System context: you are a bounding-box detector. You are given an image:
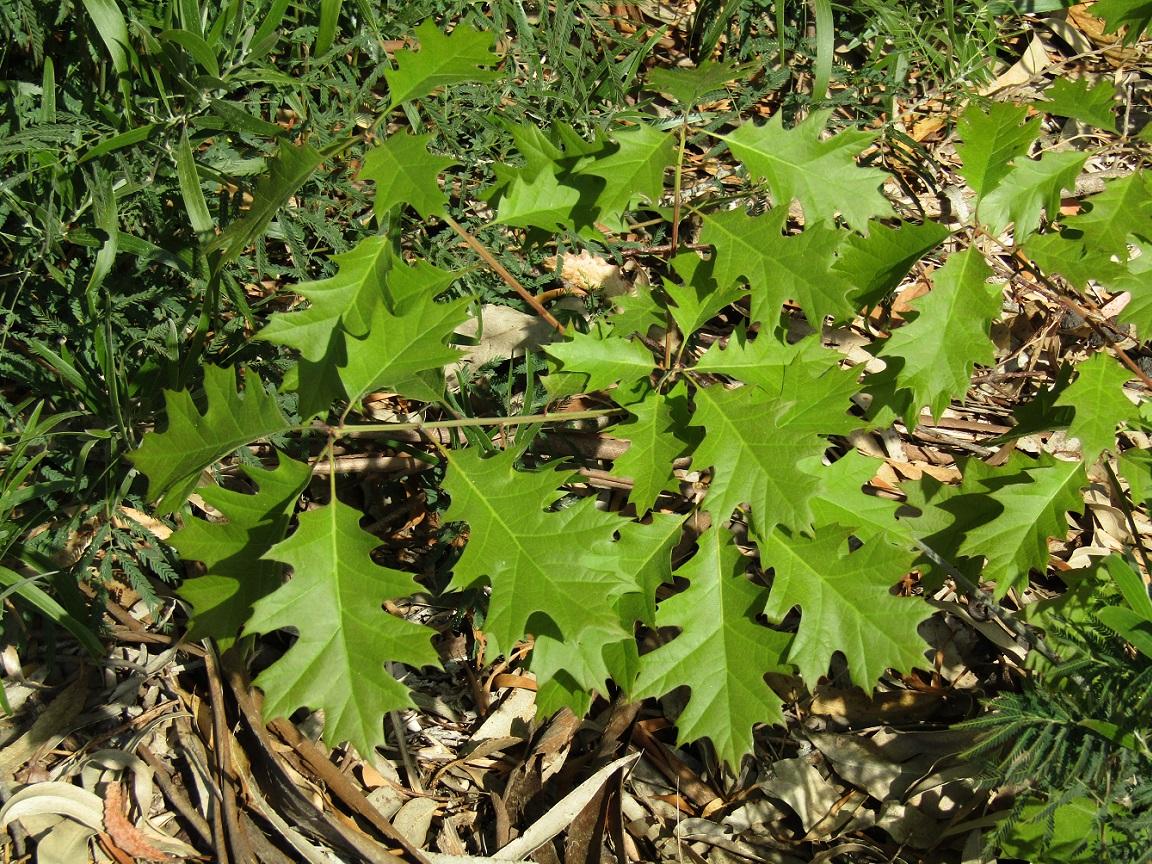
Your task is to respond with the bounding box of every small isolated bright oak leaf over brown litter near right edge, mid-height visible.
[1054,351,1140,464]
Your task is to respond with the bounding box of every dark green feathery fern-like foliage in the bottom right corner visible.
[965,576,1152,864]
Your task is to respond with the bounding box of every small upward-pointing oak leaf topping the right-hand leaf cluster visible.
[956,103,1040,197]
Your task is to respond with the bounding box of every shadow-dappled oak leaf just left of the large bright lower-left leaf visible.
[168,453,312,651]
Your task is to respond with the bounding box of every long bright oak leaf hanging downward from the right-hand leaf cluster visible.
[870,249,1002,429]
